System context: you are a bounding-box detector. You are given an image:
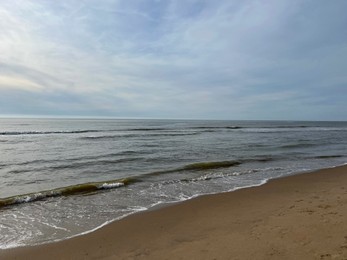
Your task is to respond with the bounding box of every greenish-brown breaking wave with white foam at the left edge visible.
[0,178,137,208]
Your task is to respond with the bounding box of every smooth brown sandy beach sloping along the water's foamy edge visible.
[0,166,347,260]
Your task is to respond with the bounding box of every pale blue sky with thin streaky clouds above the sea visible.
[0,0,347,120]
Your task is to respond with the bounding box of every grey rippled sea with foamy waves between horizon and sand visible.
[0,119,347,248]
